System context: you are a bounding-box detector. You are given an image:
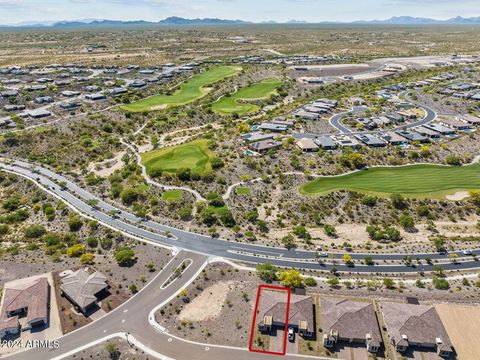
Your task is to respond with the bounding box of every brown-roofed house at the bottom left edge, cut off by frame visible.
[0,277,50,338]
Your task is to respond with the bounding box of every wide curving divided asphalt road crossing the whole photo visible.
[0,160,480,274]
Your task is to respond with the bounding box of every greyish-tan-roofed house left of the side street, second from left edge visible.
[60,268,108,314]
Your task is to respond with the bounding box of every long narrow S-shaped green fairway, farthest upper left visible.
[121,66,242,112]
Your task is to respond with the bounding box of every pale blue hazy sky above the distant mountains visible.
[0,0,480,24]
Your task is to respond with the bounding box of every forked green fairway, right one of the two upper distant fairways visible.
[212,79,282,116]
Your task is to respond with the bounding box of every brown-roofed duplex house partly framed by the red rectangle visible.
[257,291,315,338]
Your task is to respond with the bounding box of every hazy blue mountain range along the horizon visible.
[0,16,480,29]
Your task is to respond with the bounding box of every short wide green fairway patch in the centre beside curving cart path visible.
[142,139,214,174]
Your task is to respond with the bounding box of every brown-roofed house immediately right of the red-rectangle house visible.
[320,298,382,353]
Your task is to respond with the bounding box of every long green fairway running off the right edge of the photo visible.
[299,163,480,199]
